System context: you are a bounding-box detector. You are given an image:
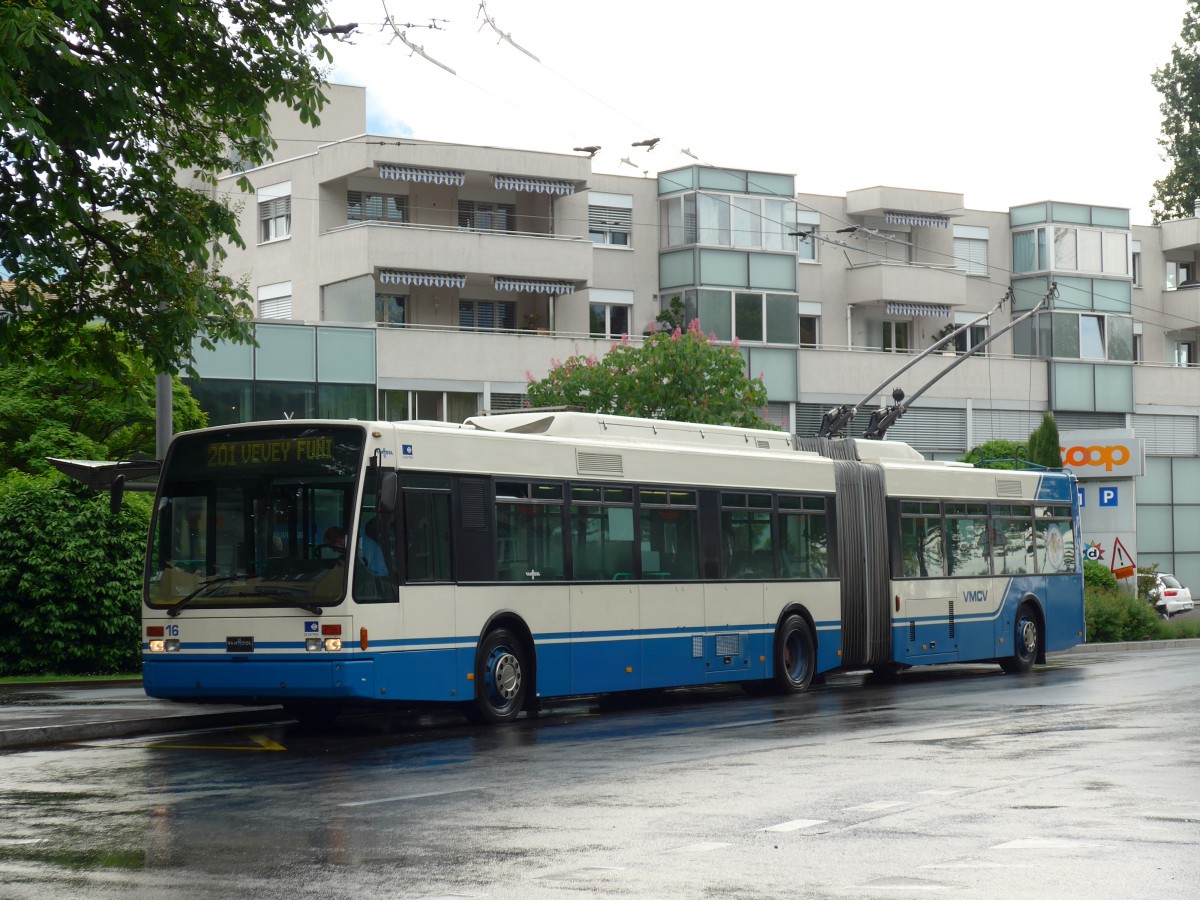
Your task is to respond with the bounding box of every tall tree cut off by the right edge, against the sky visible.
[1150,0,1200,224]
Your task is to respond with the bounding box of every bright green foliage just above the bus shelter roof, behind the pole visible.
[0,329,205,480]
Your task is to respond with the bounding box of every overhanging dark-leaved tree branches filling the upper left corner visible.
[0,0,330,373]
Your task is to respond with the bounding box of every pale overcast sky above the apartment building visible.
[329,0,1188,224]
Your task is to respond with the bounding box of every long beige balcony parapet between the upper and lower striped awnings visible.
[317,222,594,284]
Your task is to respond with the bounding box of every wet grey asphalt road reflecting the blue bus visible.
[0,648,1200,900]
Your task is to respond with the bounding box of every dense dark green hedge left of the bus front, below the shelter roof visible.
[0,473,151,676]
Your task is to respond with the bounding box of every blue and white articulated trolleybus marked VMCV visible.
[143,410,1084,722]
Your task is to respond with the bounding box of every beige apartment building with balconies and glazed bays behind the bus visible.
[184,85,1200,586]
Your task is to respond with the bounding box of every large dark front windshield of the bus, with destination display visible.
[146,425,365,614]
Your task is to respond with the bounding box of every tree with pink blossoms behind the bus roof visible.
[526,319,769,428]
